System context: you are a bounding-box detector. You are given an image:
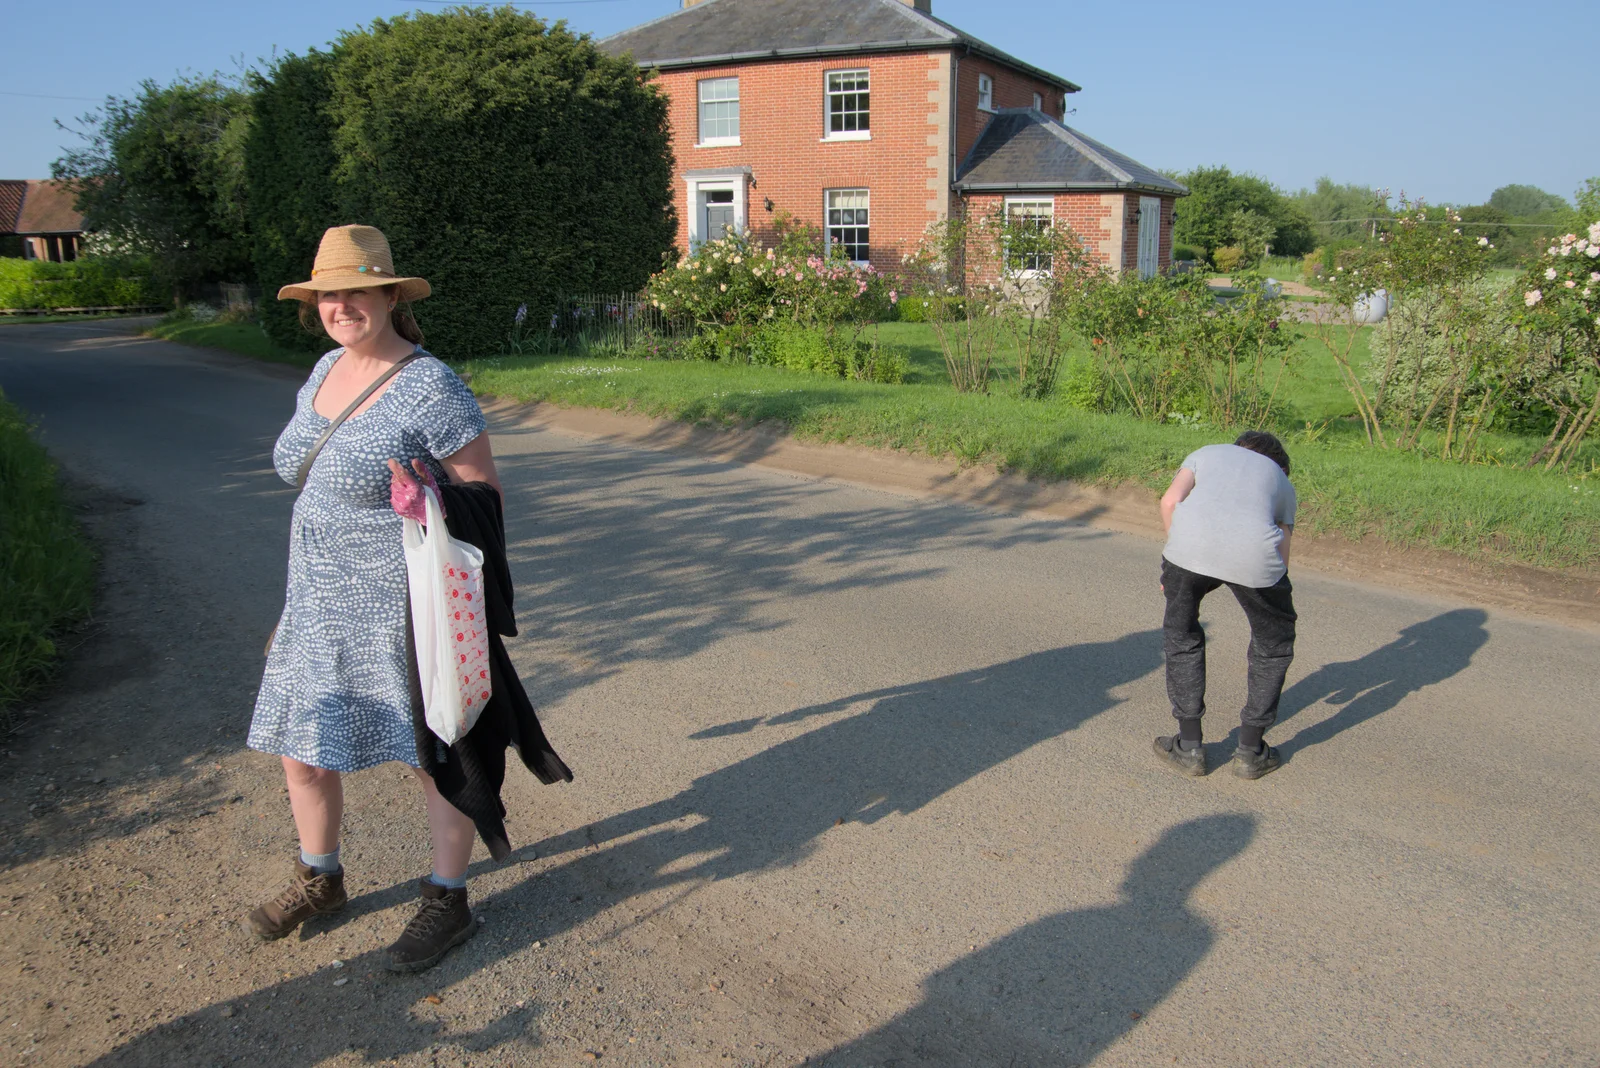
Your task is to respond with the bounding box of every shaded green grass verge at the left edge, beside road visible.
[0,393,94,735]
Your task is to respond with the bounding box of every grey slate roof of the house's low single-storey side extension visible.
[954,107,1189,197]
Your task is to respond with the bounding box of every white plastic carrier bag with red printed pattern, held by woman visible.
[405,486,491,745]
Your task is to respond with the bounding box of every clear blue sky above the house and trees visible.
[0,0,1600,203]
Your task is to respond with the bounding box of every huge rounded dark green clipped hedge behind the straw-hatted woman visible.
[245,8,675,360]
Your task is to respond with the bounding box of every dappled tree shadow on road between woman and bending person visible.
[498,430,1107,713]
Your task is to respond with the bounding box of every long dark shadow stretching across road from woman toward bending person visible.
[538,630,1162,886]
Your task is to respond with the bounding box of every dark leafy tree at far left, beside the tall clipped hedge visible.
[53,75,250,302]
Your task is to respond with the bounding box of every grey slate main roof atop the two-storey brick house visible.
[597,0,1080,93]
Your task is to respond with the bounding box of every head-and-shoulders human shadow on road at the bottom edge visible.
[814,815,1256,1068]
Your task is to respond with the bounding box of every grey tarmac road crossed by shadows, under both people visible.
[0,323,1600,1066]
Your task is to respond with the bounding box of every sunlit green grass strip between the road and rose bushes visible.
[140,314,1600,571]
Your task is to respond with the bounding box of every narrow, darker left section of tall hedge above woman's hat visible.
[245,51,346,349]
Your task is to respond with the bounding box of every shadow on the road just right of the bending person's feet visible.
[1277,608,1490,756]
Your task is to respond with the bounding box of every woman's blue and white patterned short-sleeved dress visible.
[248,349,485,771]
